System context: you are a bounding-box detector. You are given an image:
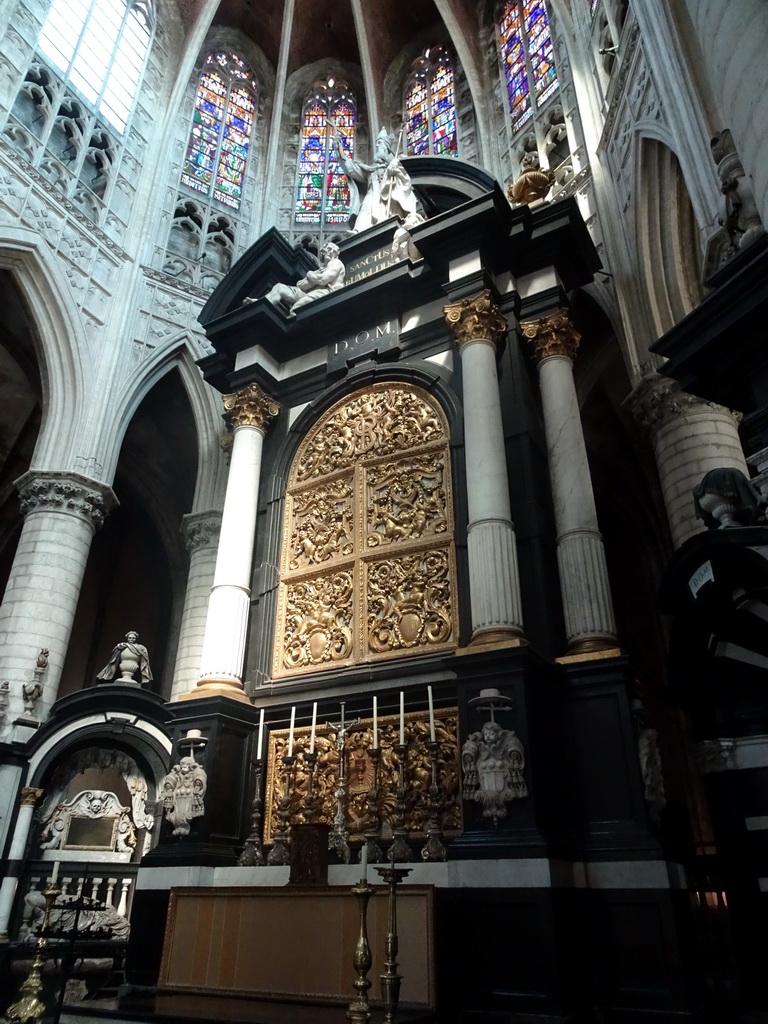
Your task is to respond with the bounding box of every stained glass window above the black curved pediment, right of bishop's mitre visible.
[404,46,458,157]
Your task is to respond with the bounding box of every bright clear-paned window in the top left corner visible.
[38,0,154,132]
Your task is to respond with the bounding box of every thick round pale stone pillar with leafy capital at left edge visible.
[0,470,118,721]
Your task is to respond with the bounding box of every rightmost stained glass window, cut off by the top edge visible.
[499,0,558,131]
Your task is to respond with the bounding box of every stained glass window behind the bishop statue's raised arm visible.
[294,80,355,226]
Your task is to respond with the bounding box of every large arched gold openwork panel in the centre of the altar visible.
[273,384,458,676]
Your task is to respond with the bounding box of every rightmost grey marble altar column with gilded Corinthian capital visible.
[520,309,617,654]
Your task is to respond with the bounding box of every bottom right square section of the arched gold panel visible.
[364,549,455,654]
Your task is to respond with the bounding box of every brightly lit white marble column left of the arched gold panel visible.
[179,384,280,700]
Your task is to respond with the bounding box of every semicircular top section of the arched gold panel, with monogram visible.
[292,384,445,483]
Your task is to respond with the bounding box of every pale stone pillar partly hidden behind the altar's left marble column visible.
[171,510,221,700]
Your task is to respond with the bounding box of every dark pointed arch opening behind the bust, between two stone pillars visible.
[59,370,198,697]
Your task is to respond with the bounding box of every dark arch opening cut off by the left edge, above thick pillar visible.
[0,270,42,595]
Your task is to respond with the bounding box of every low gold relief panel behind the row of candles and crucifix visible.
[264,708,463,844]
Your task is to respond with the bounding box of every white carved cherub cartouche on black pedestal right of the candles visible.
[462,722,528,826]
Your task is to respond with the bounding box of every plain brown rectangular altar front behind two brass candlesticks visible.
[158,886,435,1009]
